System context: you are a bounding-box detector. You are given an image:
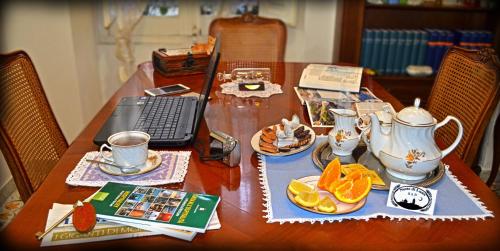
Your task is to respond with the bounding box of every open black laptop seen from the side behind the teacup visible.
[94,43,220,147]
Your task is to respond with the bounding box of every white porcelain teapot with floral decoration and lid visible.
[370,98,463,180]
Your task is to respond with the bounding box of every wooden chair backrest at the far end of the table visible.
[209,13,287,62]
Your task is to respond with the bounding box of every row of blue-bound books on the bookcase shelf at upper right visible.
[361,29,493,75]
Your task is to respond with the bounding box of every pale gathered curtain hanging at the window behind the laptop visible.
[103,0,147,82]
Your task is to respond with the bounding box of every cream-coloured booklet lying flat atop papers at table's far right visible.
[299,64,363,92]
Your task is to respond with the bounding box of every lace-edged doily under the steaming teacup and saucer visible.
[66,151,191,187]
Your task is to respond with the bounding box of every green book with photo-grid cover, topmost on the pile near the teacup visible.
[90,182,220,233]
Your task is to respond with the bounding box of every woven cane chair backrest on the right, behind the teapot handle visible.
[427,47,500,166]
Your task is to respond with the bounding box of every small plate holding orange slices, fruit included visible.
[287,159,372,215]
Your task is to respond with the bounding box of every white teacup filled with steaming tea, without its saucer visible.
[99,131,151,170]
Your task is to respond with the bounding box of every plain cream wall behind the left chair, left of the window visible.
[0,1,103,196]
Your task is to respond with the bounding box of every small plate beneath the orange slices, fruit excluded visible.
[286,176,366,215]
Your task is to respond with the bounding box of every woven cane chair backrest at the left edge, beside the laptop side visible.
[0,51,68,201]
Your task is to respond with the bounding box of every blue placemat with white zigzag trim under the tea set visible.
[259,136,493,223]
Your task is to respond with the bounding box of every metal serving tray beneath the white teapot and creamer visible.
[312,142,445,190]
